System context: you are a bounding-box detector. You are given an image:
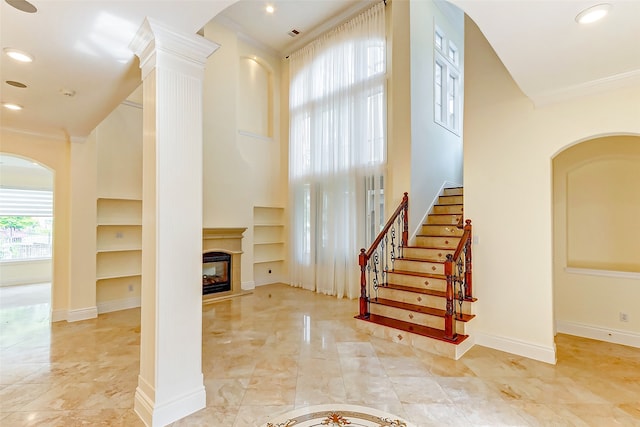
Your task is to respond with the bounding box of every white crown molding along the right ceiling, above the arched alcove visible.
[530,70,640,107]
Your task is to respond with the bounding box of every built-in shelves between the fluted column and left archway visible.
[96,198,142,302]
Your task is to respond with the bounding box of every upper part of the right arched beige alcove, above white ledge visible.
[553,135,640,272]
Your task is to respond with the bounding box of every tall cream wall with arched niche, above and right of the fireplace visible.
[203,20,288,288]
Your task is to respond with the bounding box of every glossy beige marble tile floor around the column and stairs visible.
[0,284,640,427]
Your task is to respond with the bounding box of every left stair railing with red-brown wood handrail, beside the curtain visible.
[358,193,409,319]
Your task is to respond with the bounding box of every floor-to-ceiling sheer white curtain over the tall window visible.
[289,2,386,298]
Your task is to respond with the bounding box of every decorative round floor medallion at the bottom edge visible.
[263,405,415,427]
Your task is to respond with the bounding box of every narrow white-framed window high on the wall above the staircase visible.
[433,27,460,133]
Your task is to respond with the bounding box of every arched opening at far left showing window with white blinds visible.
[0,154,54,335]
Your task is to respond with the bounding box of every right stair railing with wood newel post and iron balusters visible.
[444,219,474,341]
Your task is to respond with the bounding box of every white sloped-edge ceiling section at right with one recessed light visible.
[451,0,640,105]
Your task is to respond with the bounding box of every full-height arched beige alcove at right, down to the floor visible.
[553,136,640,343]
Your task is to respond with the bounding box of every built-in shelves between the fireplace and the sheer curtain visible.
[253,206,285,285]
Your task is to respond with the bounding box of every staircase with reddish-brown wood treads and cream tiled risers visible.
[357,187,475,359]
